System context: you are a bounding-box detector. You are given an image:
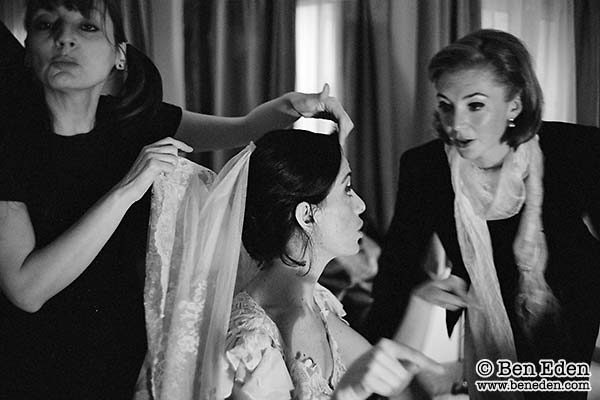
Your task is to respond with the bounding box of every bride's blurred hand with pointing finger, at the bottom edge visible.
[332,339,444,400]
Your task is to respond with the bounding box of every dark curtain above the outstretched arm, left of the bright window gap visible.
[184,0,296,170]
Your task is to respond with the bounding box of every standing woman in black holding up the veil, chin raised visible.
[0,0,351,400]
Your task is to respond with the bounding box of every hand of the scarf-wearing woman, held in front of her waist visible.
[413,275,470,311]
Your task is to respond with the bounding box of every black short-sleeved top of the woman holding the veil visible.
[0,97,181,400]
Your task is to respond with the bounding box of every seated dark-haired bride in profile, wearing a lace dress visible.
[226,132,384,399]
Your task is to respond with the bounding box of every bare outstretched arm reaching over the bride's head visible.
[175,85,354,151]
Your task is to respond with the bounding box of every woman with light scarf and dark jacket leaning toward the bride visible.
[366,30,600,399]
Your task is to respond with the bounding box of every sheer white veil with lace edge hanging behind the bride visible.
[135,143,255,400]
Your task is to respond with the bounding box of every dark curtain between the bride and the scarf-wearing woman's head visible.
[342,0,480,234]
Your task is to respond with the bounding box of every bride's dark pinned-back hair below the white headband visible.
[242,130,342,266]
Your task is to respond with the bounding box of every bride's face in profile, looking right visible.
[312,157,365,258]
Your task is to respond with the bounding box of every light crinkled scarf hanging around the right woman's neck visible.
[446,136,558,399]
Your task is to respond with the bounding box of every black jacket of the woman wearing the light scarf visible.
[365,122,600,398]
